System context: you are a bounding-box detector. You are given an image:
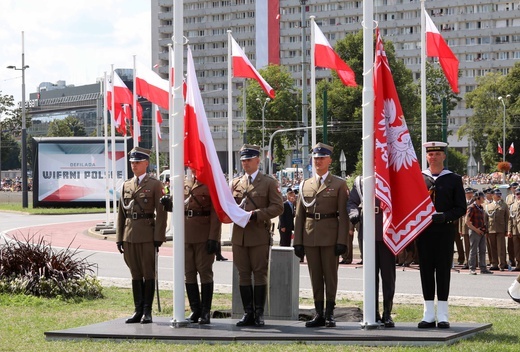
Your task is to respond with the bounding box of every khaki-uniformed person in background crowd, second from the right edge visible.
[484,189,509,271]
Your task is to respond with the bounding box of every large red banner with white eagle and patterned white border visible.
[374,30,435,255]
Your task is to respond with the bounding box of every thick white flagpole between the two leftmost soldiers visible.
[170,1,187,327]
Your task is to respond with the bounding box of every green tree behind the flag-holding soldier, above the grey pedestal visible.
[243,65,301,172]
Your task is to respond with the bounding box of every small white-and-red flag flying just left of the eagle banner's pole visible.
[313,22,357,87]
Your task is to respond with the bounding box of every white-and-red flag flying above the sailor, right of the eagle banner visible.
[424,10,459,94]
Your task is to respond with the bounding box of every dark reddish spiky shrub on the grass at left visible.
[0,236,103,300]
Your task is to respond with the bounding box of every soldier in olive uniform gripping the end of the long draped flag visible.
[231,144,283,326]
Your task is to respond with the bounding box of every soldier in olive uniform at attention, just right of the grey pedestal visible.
[294,143,350,327]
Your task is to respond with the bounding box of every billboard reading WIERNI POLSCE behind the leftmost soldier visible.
[33,137,132,207]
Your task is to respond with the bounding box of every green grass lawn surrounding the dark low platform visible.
[0,287,520,352]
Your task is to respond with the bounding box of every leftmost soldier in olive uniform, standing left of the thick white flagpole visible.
[116,147,166,324]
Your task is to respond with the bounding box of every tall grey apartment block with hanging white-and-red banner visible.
[151,0,520,170]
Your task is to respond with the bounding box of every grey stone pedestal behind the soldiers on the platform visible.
[231,246,300,320]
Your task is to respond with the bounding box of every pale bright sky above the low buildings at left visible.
[0,0,151,102]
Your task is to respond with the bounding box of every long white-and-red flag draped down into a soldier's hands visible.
[184,46,251,227]
